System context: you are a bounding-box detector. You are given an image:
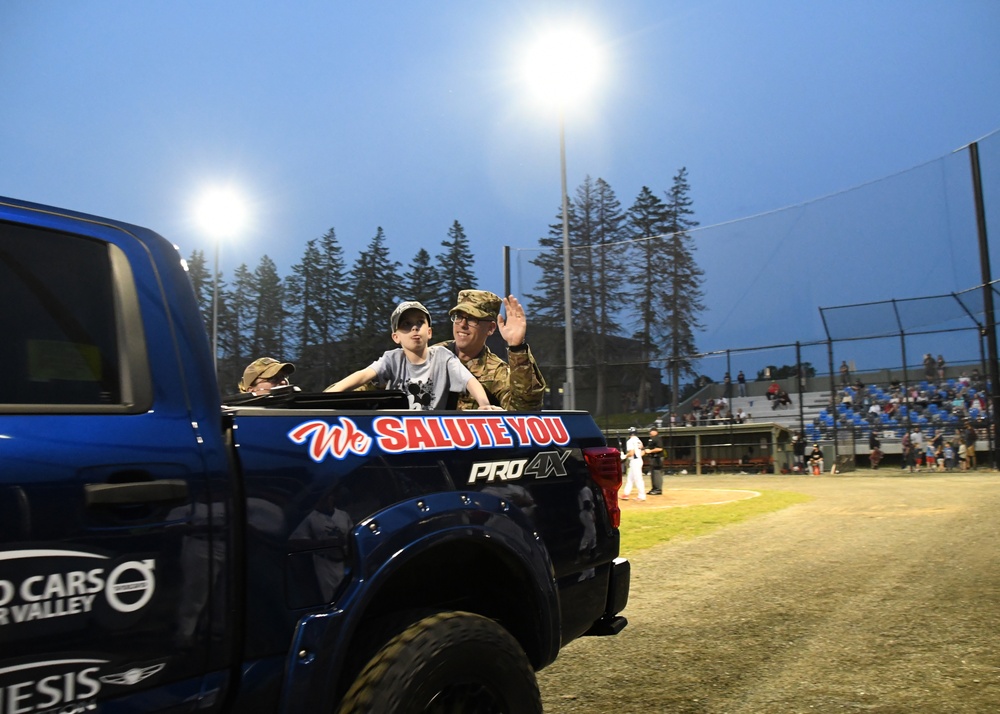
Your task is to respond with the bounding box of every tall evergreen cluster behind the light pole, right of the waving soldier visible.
[527,168,704,414]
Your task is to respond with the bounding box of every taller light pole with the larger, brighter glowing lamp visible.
[524,26,604,409]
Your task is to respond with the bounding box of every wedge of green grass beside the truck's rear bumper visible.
[621,491,813,556]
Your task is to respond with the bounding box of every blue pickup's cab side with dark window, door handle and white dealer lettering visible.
[0,207,227,714]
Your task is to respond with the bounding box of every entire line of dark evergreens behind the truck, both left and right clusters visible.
[188,168,704,414]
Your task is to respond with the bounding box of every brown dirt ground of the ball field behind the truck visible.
[538,469,1000,714]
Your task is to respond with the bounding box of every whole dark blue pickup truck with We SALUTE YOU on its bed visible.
[0,198,629,714]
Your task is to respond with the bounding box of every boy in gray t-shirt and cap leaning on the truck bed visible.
[326,300,495,409]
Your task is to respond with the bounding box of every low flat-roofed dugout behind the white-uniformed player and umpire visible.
[605,422,793,474]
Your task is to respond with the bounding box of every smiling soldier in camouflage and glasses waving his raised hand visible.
[441,290,545,411]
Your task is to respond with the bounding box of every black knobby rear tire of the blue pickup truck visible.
[337,612,542,714]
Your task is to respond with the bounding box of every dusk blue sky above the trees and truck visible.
[0,0,1000,378]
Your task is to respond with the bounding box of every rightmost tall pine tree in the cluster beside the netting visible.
[658,168,705,408]
